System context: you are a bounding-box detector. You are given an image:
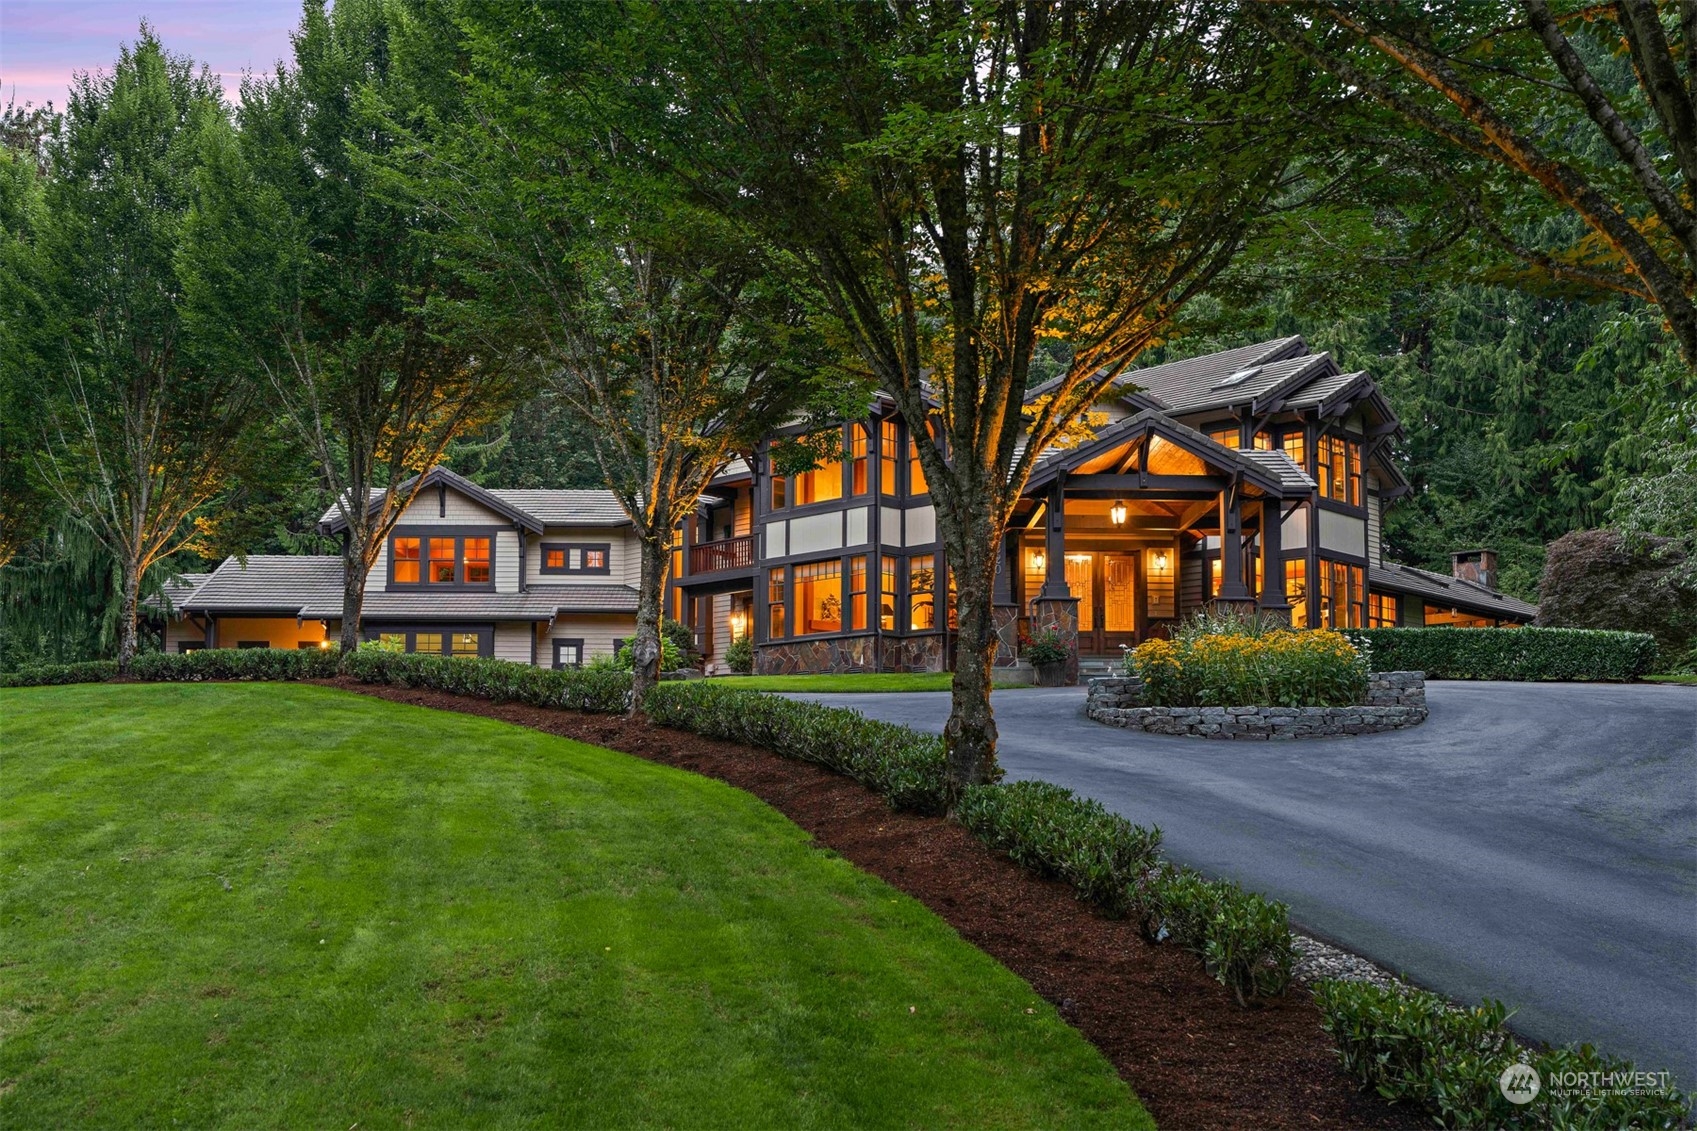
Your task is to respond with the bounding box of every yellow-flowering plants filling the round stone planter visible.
[1127,618,1368,706]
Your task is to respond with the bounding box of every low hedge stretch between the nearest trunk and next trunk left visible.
[645,679,947,813]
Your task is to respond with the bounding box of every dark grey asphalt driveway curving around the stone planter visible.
[794,683,1697,1089]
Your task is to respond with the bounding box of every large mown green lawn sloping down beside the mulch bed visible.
[0,684,1151,1128]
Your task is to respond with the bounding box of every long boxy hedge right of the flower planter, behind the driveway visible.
[1344,628,1656,681]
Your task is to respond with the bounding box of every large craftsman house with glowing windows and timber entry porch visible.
[156,336,1537,672]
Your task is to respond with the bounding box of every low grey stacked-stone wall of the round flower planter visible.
[1084,671,1427,740]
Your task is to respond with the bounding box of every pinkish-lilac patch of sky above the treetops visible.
[0,0,300,110]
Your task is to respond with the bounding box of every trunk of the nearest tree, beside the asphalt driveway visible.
[938,540,1001,791]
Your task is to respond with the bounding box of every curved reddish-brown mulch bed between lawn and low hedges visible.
[329,679,1425,1128]
